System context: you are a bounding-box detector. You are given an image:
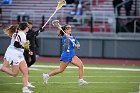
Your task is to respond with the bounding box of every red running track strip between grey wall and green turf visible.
[0,56,140,65]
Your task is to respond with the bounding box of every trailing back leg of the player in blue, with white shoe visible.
[43,61,69,84]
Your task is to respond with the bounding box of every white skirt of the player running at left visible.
[4,47,25,65]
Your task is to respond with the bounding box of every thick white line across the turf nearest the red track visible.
[30,65,140,71]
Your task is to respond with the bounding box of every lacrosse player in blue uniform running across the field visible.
[43,25,88,85]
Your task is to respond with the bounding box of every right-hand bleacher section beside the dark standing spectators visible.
[79,0,136,32]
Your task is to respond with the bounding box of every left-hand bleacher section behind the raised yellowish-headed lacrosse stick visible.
[0,0,72,30]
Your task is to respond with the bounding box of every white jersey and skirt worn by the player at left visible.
[4,31,26,65]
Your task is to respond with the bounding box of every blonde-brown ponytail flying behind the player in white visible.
[4,25,18,37]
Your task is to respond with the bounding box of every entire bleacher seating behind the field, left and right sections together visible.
[0,0,135,32]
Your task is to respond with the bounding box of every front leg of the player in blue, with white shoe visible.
[72,56,87,85]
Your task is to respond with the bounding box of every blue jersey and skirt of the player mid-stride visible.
[60,35,78,62]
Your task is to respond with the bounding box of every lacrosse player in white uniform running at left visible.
[1,23,33,93]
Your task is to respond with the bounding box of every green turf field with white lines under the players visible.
[0,62,140,93]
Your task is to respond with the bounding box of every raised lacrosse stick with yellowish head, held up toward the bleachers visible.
[42,0,66,29]
